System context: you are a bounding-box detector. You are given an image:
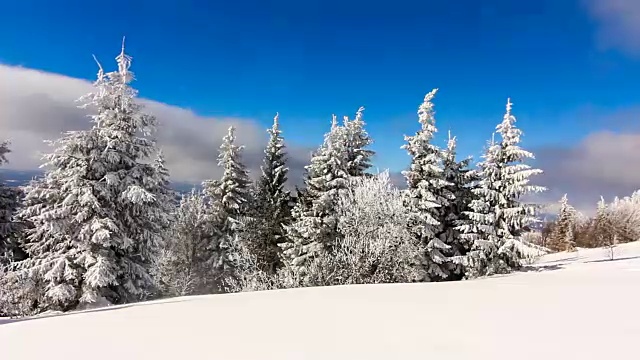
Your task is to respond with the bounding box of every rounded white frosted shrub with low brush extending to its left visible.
[227,172,425,291]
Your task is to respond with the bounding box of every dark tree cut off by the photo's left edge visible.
[0,141,23,266]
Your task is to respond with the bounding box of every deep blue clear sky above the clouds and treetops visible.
[0,0,640,174]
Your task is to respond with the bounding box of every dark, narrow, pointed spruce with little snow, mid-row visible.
[241,114,291,273]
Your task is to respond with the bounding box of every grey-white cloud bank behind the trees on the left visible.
[0,65,309,183]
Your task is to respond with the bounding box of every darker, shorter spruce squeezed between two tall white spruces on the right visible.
[438,134,478,280]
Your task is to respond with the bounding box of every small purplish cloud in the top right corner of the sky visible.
[584,0,640,55]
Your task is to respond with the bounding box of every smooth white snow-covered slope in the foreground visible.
[0,243,640,360]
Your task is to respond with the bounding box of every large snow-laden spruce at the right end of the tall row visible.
[460,100,545,277]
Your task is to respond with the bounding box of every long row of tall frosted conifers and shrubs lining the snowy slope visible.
[0,43,544,315]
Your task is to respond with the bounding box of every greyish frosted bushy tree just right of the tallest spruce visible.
[155,190,220,296]
